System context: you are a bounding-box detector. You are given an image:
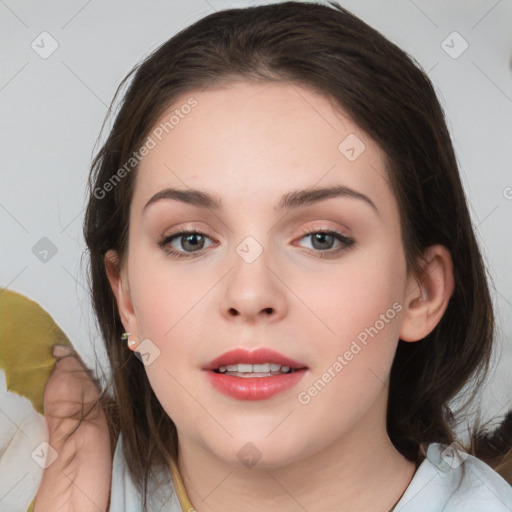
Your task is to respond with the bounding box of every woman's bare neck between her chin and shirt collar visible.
[174,402,416,512]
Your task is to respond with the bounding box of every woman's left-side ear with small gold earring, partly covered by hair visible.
[104,250,139,350]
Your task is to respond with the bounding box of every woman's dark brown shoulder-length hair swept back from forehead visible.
[84,2,510,504]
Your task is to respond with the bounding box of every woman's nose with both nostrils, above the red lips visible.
[220,244,288,324]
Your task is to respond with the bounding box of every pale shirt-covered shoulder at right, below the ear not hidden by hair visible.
[393,443,512,512]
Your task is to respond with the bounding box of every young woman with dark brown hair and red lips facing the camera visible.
[37,2,512,512]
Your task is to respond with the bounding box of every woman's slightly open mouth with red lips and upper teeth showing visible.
[202,348,308,400]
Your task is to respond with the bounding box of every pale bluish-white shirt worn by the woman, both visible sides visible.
[110,436,512,512]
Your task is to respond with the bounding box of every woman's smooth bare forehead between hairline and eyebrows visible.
[133,82,391,214]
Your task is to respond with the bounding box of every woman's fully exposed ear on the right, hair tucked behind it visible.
[400,245,454,341]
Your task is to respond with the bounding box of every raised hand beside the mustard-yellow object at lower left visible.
[34,346,112,512]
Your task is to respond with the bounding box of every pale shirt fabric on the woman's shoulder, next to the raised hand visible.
[109,434,181,512]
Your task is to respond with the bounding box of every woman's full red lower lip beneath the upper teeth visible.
[206,368,307,400]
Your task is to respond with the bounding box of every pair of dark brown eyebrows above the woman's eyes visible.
[143,185,380,215]
